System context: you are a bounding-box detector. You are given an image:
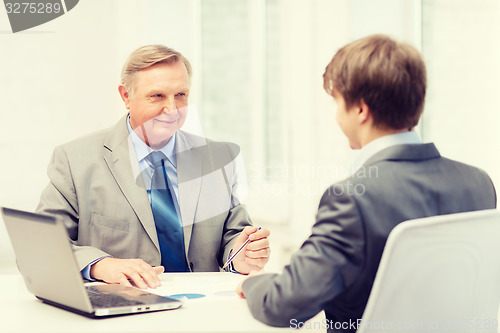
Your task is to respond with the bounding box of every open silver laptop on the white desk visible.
[2,208,182,318]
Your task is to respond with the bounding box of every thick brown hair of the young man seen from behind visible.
[323,35,427,130]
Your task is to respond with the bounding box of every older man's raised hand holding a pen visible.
[232,227,271,274]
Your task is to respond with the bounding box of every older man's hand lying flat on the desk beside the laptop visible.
[90,258,164,289]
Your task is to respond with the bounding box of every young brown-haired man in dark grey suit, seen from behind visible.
[237,35,496,332]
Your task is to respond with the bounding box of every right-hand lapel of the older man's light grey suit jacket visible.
[175,131,203,252]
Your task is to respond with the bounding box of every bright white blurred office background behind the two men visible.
[0,0,500,272]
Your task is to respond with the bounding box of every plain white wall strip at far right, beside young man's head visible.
[423,0,500,189]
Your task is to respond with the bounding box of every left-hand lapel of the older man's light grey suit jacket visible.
[104,117,160,251]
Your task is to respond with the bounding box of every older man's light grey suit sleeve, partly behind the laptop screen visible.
[36,147,109,270]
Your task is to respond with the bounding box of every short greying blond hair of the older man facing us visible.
[121,45,192,93]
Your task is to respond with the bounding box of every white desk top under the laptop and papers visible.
[0,273,326,333]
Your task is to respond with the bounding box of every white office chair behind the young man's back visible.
[358,210,500,333]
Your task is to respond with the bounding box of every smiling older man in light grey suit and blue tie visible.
[38,45,269,288]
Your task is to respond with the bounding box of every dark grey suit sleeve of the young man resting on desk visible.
[243,187,365,327]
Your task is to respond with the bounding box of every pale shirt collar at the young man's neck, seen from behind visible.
[349,131,422,174]
